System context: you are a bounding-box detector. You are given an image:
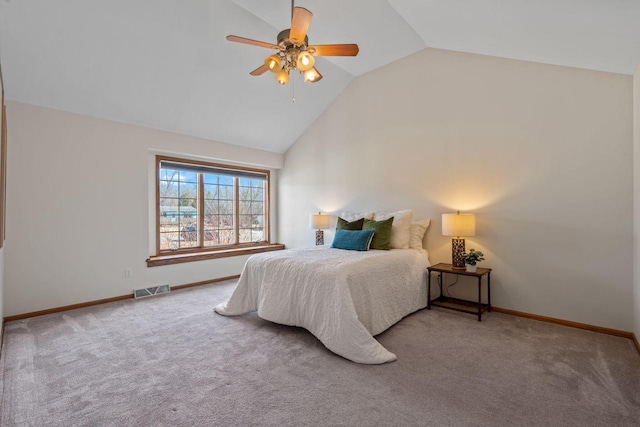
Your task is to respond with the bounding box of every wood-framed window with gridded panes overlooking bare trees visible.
[156,156,269,255]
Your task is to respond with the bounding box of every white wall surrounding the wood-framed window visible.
[4,102,283,316]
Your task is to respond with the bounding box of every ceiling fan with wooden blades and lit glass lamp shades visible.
[227,0,359,85]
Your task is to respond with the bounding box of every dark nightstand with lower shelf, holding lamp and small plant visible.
[427,263,491,322]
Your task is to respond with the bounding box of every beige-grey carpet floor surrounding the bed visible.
[0,282,640,426]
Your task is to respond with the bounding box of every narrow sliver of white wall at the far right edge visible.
[633,65,640,339]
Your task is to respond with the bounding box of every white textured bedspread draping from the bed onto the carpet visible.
[215,246,429,364]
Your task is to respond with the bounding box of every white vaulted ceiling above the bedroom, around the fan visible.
[0,0,640,152]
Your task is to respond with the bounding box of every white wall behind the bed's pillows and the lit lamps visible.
[278,49,633,331]
